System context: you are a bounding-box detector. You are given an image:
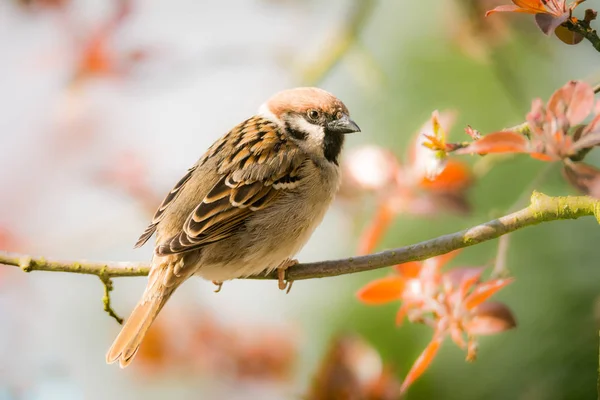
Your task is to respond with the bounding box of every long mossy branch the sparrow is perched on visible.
[0,192,600,284]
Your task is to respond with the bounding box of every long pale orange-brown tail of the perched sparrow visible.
[106,291,172,368]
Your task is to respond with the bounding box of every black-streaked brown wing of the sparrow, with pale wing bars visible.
[156,117,305,255]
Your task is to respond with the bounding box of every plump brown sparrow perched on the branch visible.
[106,87,360,368]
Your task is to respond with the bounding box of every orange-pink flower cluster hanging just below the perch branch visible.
[357,251,516,392]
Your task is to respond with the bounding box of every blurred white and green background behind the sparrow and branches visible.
[0,0,600,400]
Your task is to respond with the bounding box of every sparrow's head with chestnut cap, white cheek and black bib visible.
[259,87,360,164]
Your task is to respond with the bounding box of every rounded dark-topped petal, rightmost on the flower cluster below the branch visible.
[466,302,517,335]
